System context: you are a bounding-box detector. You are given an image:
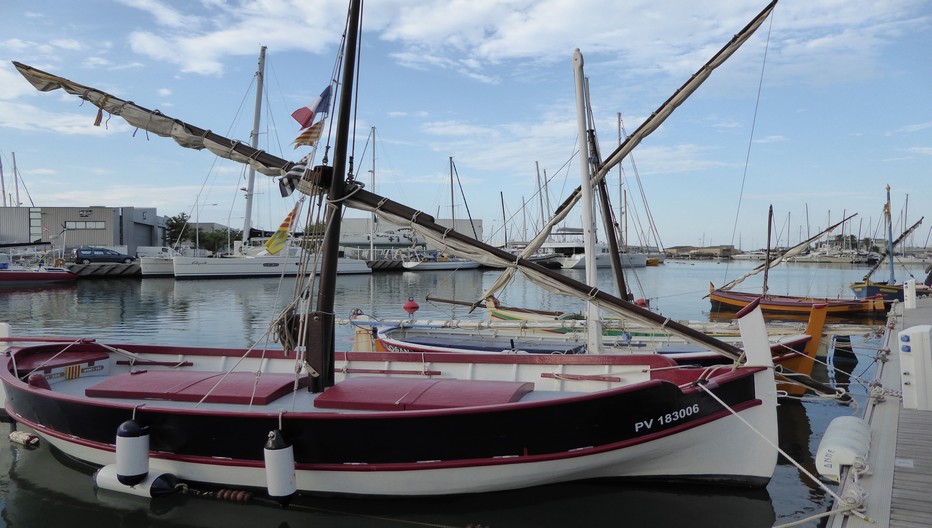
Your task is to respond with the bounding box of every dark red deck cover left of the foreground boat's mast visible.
[84,370,307,405]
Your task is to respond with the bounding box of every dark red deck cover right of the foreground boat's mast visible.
[314,377,534,411]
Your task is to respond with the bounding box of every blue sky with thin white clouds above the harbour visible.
[0,0,932,250]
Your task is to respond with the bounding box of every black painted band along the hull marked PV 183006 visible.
[5,368,759,469]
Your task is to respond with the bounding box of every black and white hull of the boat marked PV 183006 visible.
[0,344,776,495]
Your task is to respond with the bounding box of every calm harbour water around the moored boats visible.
[0,261,896,528]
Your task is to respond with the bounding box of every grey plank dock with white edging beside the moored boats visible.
[816,288,932,528]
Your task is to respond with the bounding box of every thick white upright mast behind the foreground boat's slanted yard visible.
[573,48,602,354]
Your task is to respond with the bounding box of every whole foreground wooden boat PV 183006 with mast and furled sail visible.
[0,0,777,502]
